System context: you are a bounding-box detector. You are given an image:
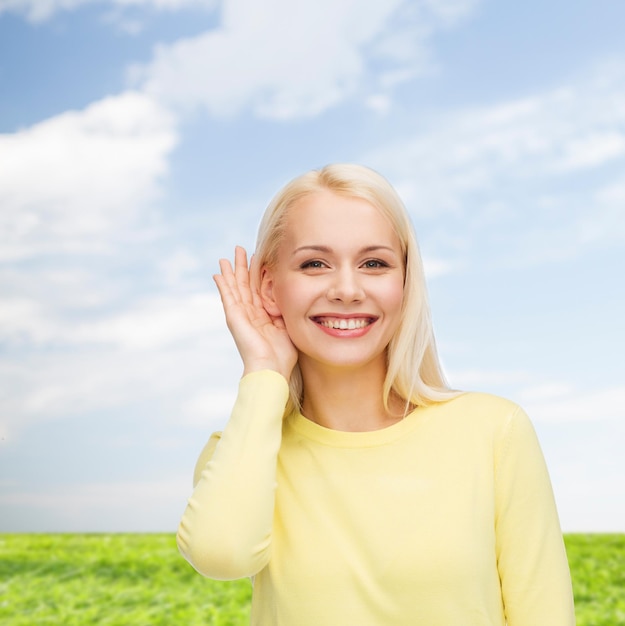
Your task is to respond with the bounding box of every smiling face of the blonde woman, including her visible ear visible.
[261,191,404,368]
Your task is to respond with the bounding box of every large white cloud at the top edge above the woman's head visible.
[131,0,476,119]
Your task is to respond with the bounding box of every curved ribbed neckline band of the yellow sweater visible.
[287,407,427,448]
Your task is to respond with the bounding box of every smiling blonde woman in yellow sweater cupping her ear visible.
[178,165,575,626]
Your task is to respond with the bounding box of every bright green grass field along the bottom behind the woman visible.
[0,534,625,626]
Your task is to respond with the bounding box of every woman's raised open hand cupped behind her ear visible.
[213,246,297,380]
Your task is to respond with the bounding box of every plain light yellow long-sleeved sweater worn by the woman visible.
[178,371,575,626]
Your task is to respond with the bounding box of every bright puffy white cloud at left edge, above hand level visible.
[0,92,177,260]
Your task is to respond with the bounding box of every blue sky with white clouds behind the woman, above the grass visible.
[0,0,625,531]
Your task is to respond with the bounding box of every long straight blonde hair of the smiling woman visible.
[255,164,457,413]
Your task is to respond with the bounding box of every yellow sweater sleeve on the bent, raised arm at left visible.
[176,370,289,580]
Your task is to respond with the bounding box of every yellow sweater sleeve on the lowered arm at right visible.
[495,408,575,626]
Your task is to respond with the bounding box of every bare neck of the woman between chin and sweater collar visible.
[300,356,405,432]
